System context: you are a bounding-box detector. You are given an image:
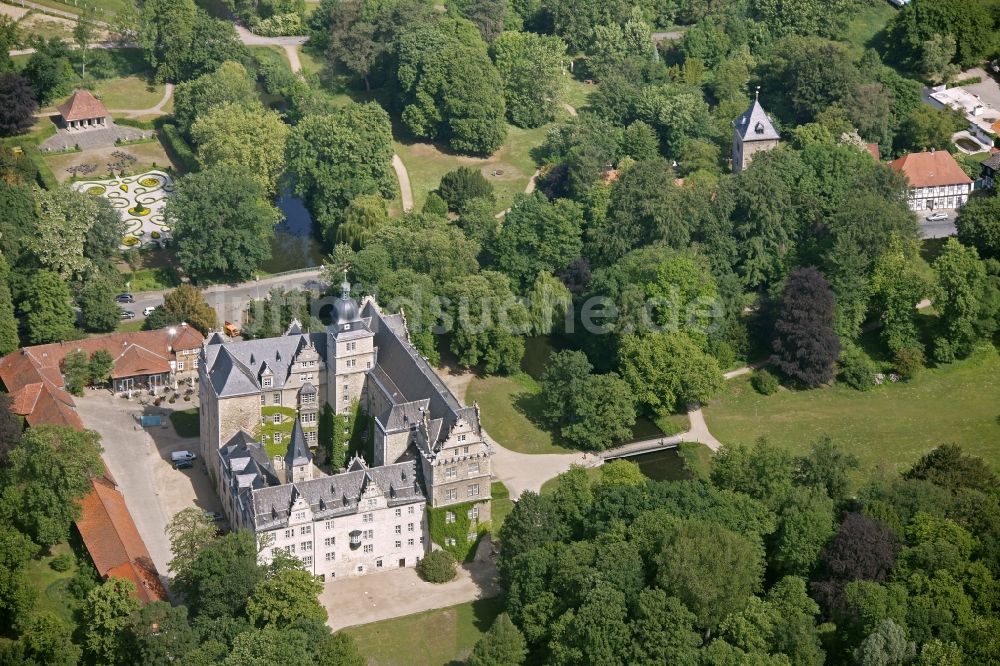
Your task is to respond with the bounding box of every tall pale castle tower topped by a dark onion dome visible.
[326,271,375,414]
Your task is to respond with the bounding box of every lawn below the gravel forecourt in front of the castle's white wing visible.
[343,597,504,666]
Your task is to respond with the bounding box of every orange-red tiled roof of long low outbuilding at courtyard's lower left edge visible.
[76,478,167,603]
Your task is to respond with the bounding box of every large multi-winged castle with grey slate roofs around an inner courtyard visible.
[198,281,492,578]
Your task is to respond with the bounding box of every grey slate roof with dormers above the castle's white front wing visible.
[250,460,427,530]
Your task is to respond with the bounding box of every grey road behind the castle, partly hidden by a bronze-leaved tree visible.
[120,268,326,324]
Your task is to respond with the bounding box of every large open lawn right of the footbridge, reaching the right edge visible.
[705,349,1000,479]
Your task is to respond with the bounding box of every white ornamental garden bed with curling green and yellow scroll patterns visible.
[73,171,174,249]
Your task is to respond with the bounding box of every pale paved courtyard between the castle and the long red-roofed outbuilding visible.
[76,391,221,576]
